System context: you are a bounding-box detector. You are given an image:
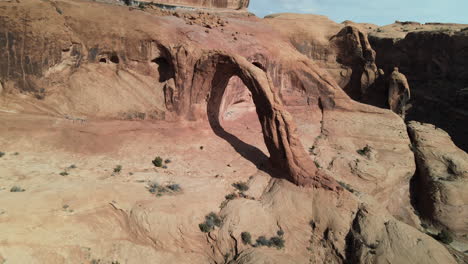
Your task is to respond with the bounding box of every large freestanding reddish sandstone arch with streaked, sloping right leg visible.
[191,52,336,189]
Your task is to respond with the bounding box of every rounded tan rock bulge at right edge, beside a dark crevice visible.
[408,122,468,240]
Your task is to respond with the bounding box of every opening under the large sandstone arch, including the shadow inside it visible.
[207,65,275,171]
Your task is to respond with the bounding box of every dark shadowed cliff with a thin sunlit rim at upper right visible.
[369,28,468,151]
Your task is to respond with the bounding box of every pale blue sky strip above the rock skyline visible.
[249,0,468,25]
